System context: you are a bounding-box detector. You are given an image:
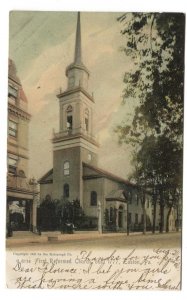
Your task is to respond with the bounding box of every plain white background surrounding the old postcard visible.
[0,0,187,300]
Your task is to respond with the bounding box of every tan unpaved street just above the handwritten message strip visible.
[7,232,181,251]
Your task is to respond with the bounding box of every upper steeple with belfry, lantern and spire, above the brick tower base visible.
[57,13,94,138]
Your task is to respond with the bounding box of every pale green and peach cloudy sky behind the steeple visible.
[9,11,132,179]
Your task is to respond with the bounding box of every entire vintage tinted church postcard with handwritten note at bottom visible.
[6,10,185,291]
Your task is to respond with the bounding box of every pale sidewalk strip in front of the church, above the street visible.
[6,231,126,247]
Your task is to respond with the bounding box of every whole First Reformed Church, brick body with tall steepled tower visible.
[39,13,176,231]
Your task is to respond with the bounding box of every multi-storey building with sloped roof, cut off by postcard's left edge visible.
[7,59,36,230]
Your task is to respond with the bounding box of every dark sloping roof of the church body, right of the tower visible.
[83,162,136,186]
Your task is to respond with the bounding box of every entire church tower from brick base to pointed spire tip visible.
[53,13,98,204]
